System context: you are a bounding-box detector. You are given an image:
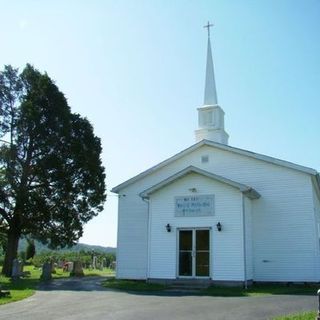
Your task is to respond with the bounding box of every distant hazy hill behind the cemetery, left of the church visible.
[18,239,117,253]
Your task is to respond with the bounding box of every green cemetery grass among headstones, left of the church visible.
[0,266,113,305]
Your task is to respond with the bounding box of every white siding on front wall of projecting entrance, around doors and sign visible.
[149,173,243,280]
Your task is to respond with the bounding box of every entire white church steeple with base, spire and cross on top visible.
[195,22,229,144]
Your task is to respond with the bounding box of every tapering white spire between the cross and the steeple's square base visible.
[203,37,218,105]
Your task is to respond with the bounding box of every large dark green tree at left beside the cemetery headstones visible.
[0,65,105,276]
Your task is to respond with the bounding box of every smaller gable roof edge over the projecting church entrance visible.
[140,166,260,199]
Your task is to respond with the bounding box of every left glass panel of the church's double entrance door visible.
[179,230,193,277]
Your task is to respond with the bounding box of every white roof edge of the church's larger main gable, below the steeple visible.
[111,140,320,193]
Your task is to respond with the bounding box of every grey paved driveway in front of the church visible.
[0,277,317,320]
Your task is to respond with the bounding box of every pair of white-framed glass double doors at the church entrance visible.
[178,229,210,278]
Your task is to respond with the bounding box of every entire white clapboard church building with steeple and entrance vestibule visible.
[112,25,320,284]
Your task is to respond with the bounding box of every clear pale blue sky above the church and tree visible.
[0,0,320,246]
